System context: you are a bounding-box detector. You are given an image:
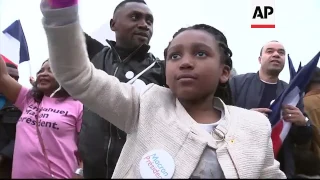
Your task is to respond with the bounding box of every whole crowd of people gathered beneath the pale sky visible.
[0,0,320,179]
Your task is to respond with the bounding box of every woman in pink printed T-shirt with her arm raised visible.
[0,59,83,178]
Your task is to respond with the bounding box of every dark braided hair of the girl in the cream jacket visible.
[164,24,233,105]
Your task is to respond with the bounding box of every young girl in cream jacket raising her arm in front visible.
[41,0,285,179]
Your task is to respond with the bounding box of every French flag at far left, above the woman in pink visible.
[0,20,30,66]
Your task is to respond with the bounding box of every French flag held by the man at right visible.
[268,52,320,157]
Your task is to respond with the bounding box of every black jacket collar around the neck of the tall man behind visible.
[106,39,150,61]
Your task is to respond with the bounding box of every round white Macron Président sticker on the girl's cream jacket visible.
[139,149,175,179]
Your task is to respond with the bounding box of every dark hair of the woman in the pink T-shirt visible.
[29,59,70,103]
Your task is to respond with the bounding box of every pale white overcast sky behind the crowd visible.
[0,0,320,86]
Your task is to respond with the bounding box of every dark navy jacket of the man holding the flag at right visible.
[229,73,312,178]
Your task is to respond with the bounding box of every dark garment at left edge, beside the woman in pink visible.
[0,102,21,178]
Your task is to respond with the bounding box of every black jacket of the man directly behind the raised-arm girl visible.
[79,35,165,178]
